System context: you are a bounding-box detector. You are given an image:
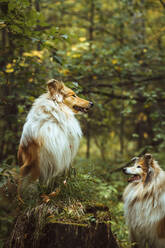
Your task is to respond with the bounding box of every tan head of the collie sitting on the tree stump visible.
[47,79,93,113]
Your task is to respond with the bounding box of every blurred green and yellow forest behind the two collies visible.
[0,0,165,247]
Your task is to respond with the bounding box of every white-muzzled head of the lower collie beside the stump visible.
[123,153,154,183]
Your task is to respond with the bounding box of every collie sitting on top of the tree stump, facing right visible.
[18,79,93,188]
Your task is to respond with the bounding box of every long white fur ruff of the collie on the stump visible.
[20,93,82,183]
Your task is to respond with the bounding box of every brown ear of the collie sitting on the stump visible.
[47,79,64,100]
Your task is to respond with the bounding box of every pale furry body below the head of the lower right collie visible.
[123,161,165,248]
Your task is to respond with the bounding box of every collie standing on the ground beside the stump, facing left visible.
[123,154,165,248]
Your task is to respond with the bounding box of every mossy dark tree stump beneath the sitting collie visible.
[5,204,118,248]
